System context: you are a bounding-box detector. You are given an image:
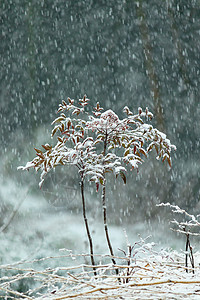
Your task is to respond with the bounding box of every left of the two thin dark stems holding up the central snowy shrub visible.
[80,177,97,276]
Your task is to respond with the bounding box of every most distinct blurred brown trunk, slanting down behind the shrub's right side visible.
[136,0,165,131]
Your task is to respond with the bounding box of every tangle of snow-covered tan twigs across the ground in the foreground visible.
[0,244,200,300]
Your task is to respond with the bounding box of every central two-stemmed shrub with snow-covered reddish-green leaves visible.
[19,96,176,273]
